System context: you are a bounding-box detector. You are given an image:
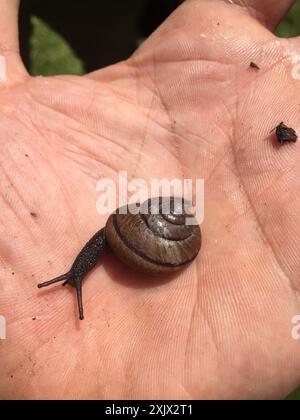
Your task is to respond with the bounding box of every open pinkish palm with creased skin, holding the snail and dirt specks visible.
[0,0,300,399]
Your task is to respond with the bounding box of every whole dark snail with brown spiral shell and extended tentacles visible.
[38,197,201,320]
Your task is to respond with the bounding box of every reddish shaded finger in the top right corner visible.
[232,0,295,30]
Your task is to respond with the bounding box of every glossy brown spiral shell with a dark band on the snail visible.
[105,197,201,274]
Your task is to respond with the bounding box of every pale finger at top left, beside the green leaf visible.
[0,0,27,86]
